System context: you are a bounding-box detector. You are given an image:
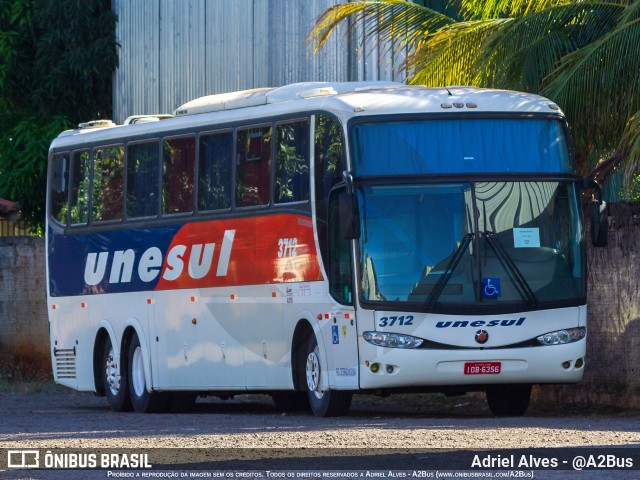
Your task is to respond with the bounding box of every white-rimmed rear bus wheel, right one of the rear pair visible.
[127,334,168,413]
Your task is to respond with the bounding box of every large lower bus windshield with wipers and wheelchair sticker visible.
[358,180,585,311]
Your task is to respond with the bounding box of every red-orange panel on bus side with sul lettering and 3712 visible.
[156,214,322,290]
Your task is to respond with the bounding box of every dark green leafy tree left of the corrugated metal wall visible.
[0,0,117,231]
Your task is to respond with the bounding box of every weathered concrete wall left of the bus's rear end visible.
[0,237,51,377]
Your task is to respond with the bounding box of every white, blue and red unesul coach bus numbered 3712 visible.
[46,82,606,416]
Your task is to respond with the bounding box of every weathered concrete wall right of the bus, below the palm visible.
[538,202,640,408]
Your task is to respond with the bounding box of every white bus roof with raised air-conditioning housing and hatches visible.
[51,82,562,148]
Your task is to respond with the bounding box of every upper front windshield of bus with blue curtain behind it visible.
[352,118,575,177]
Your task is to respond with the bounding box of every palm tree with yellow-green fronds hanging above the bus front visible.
[309,0,640,189]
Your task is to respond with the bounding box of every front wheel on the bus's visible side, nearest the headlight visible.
[305,335,352,417]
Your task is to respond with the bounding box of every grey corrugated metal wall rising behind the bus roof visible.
[112,0,412,123]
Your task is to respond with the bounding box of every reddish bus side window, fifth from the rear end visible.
[162,137,196,214]
